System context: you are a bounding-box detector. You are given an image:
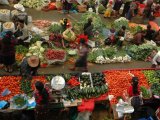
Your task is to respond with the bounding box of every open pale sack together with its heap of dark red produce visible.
[45,49,66,64]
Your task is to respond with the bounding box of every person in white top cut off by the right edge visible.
[152,49,160,68]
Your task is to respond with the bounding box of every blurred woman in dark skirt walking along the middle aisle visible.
[70,39,88,72]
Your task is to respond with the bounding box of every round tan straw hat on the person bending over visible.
[27,55,40,67]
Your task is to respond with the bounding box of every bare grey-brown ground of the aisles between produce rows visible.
[0,6,151,75]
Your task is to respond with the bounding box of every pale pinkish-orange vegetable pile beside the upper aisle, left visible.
[33,20,51,29]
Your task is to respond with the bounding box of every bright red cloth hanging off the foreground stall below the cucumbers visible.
[78,99,94,112]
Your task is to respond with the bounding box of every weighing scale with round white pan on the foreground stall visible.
[51,76,65,102]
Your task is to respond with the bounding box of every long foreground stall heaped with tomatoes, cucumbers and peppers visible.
[0,69,160,118]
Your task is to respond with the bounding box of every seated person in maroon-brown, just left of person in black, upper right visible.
[133,31,145,45]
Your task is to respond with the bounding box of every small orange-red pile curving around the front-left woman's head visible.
[31,76,47,90]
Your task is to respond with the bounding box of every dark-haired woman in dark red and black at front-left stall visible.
[34,81,49,120]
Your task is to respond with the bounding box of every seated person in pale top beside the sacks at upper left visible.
[14,20,29,45]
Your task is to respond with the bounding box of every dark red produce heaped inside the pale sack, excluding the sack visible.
[45,49,66,60]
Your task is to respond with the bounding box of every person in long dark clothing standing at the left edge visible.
[0,31,16,72]
